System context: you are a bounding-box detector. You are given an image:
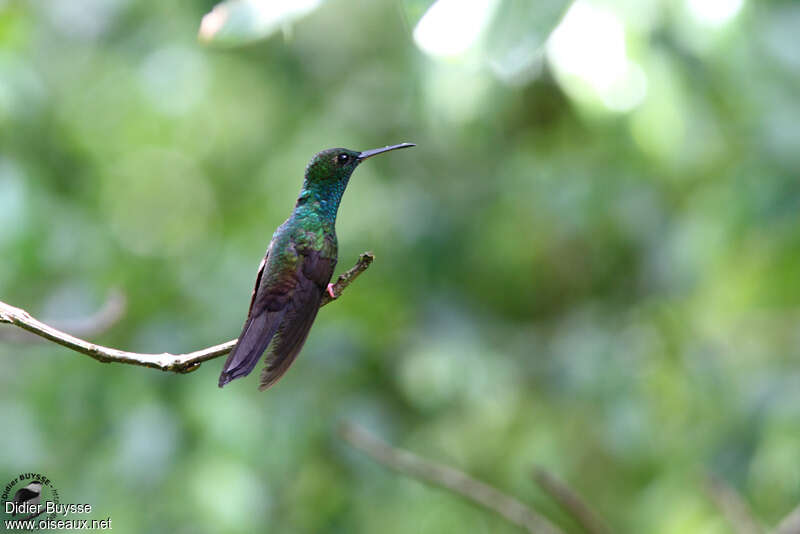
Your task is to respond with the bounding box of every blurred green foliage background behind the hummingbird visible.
[0,0,800,533]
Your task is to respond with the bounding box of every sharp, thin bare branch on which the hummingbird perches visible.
[0,252,374,373]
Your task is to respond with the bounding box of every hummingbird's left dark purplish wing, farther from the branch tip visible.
[219,244,286,387]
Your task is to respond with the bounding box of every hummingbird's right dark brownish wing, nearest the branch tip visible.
[258,249,336,391]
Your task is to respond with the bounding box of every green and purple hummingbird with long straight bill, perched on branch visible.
[219,143,415,391]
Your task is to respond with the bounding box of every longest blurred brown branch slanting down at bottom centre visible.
[340,423,563,534]
